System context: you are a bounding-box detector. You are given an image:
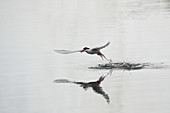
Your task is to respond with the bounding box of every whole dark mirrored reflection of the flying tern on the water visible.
[54,75,110,103]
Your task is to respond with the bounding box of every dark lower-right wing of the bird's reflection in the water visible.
[92,86,110,103]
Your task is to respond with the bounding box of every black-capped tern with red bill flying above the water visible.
[54,42,110,61]
